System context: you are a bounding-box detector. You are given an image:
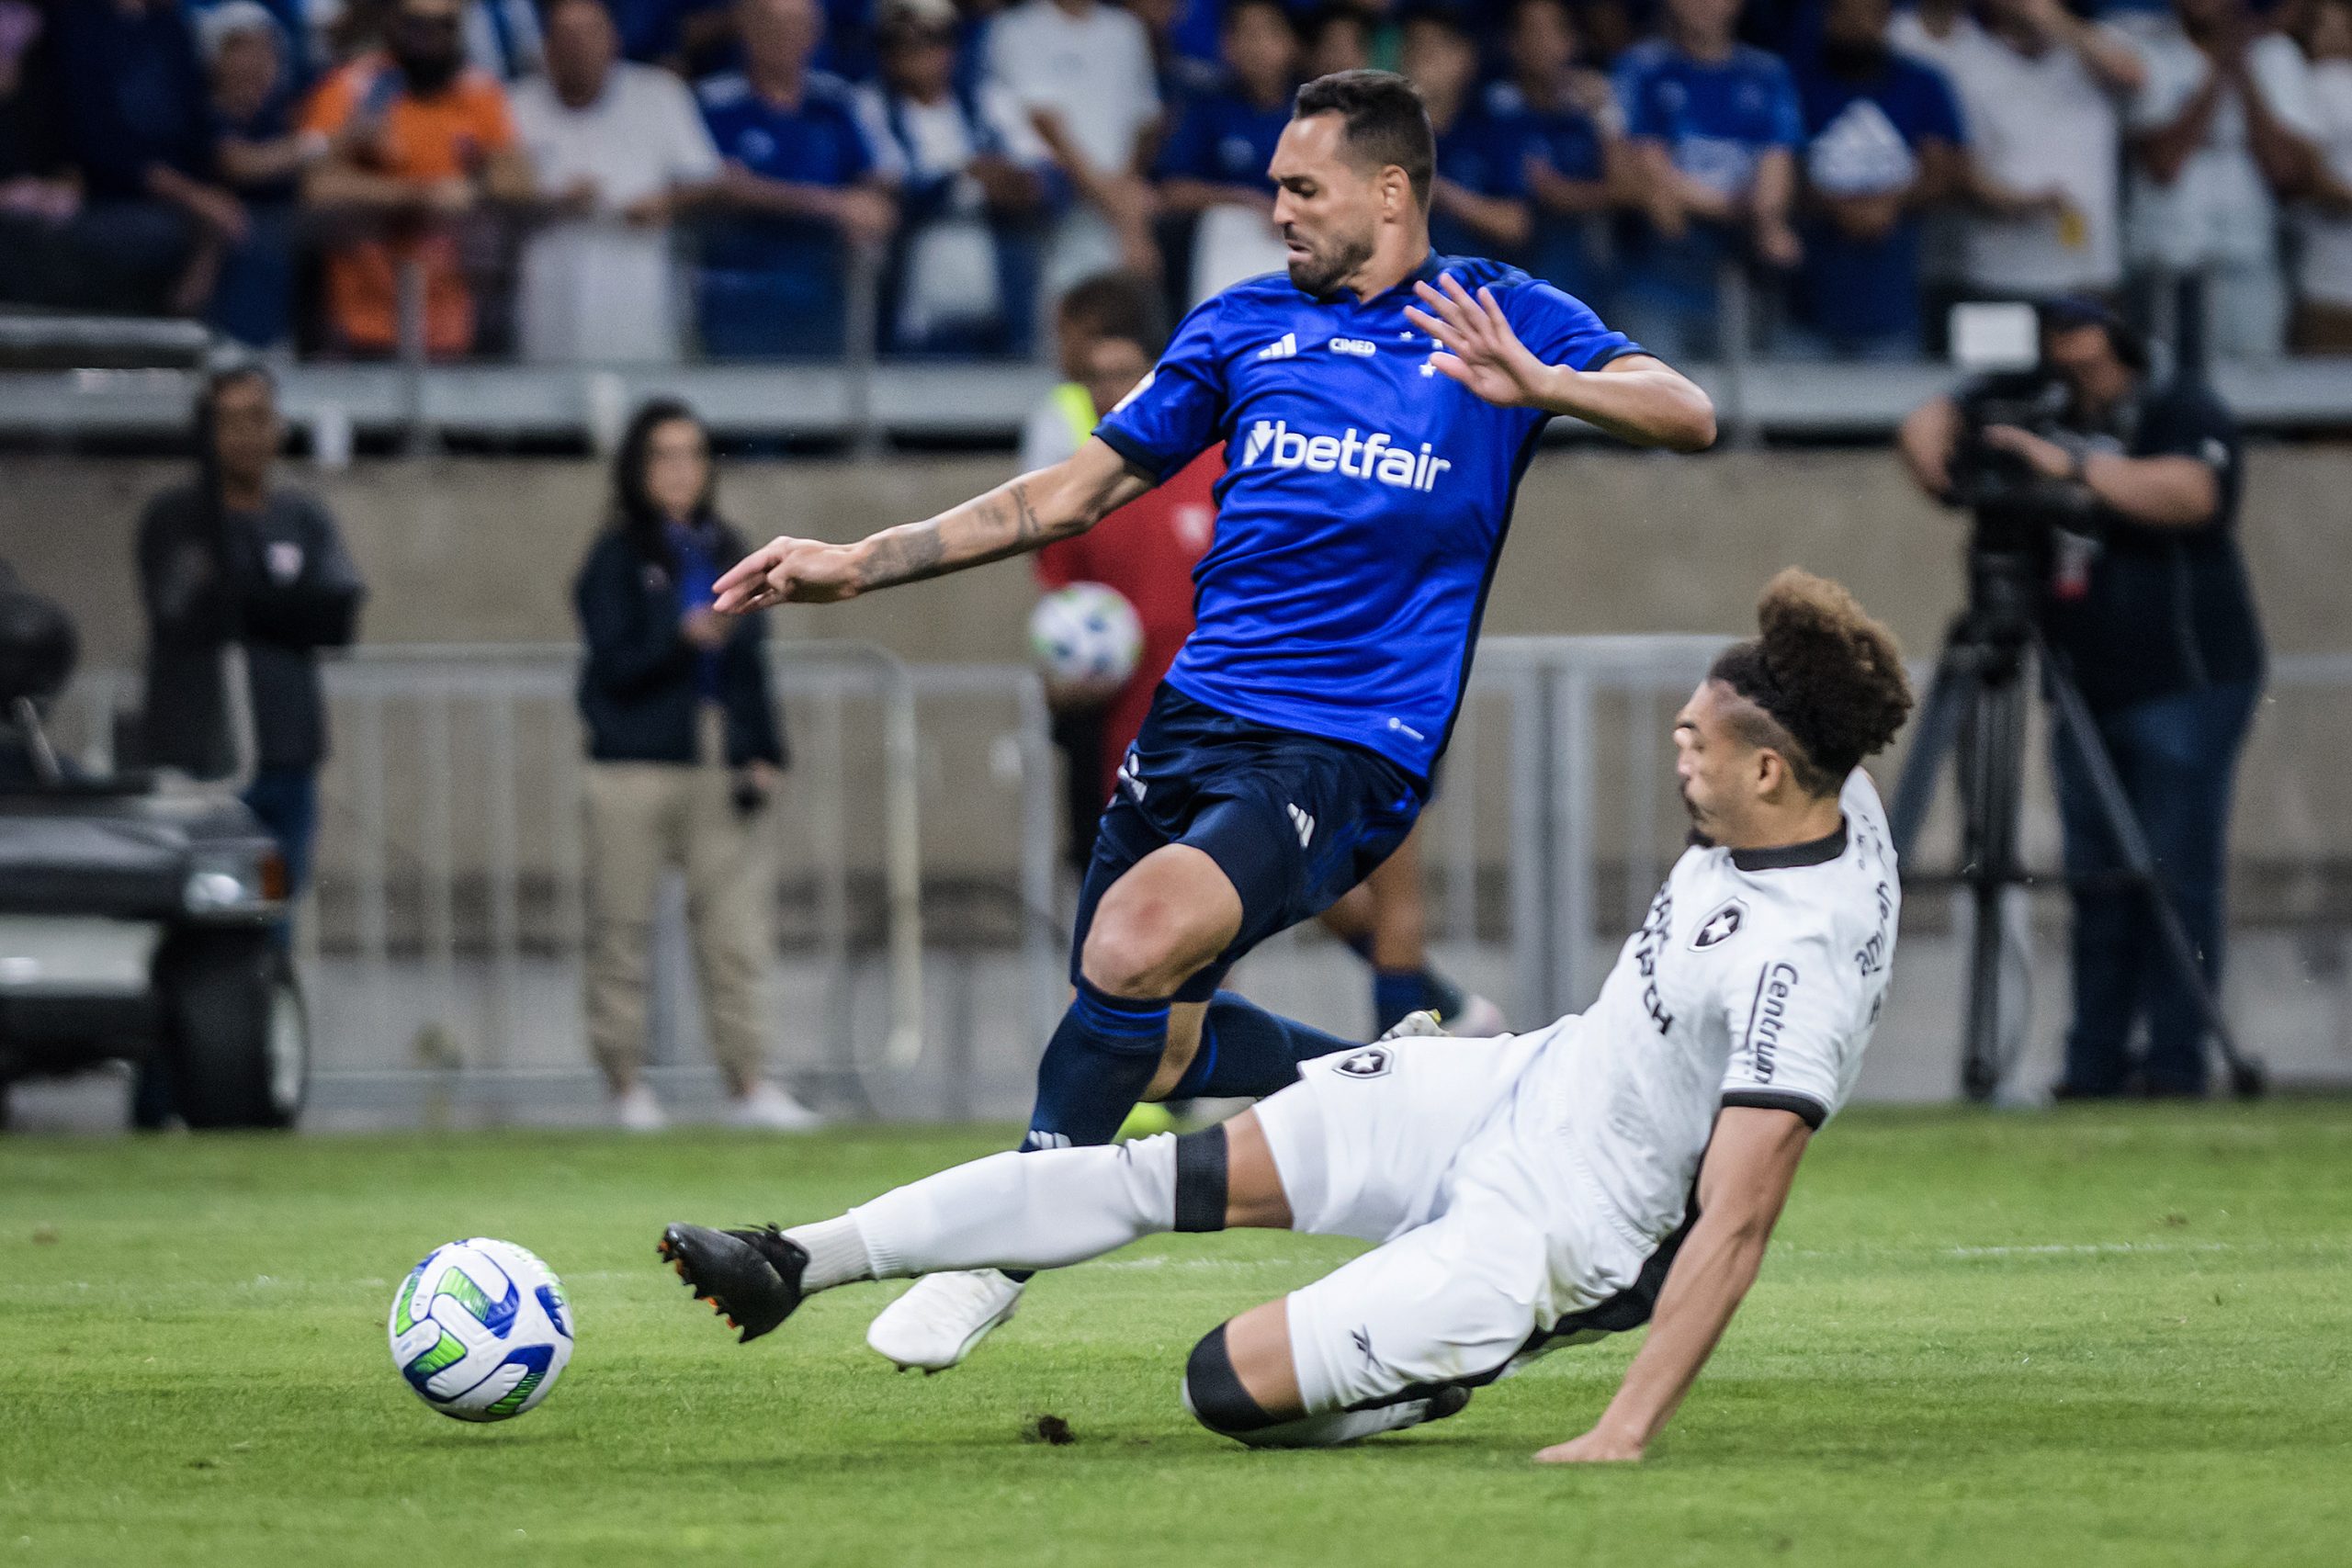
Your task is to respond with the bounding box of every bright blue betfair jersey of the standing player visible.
[1096,256,1639,776]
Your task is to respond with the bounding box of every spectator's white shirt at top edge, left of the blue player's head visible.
[988,0,1159,174]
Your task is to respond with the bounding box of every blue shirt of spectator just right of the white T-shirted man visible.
[694,71,875,273]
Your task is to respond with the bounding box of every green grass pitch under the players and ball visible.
[0,1102,2352,1568]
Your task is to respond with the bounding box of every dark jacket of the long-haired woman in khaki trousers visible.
[571,525,786,766]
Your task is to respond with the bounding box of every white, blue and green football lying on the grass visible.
[386,1236,571,1420]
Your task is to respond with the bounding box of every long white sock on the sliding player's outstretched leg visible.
[851,1134,1176,1279]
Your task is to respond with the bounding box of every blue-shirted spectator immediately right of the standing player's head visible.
[1399,5,1536,261]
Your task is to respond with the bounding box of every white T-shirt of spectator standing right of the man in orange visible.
[513,62,719,362]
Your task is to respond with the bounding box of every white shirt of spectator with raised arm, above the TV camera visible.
[1936,28,2124,296]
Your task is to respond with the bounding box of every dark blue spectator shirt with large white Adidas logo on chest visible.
[1797,54,1962,345]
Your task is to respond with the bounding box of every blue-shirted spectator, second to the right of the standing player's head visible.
[1487,0,1625,303]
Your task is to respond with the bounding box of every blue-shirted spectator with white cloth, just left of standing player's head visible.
[1155,0,1298,303]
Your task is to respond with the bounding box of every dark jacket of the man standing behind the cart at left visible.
[139,484,367,778]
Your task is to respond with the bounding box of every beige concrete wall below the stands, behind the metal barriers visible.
[14,446,2352,858]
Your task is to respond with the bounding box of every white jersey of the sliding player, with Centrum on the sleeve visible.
[1536,769,1903,1248]
